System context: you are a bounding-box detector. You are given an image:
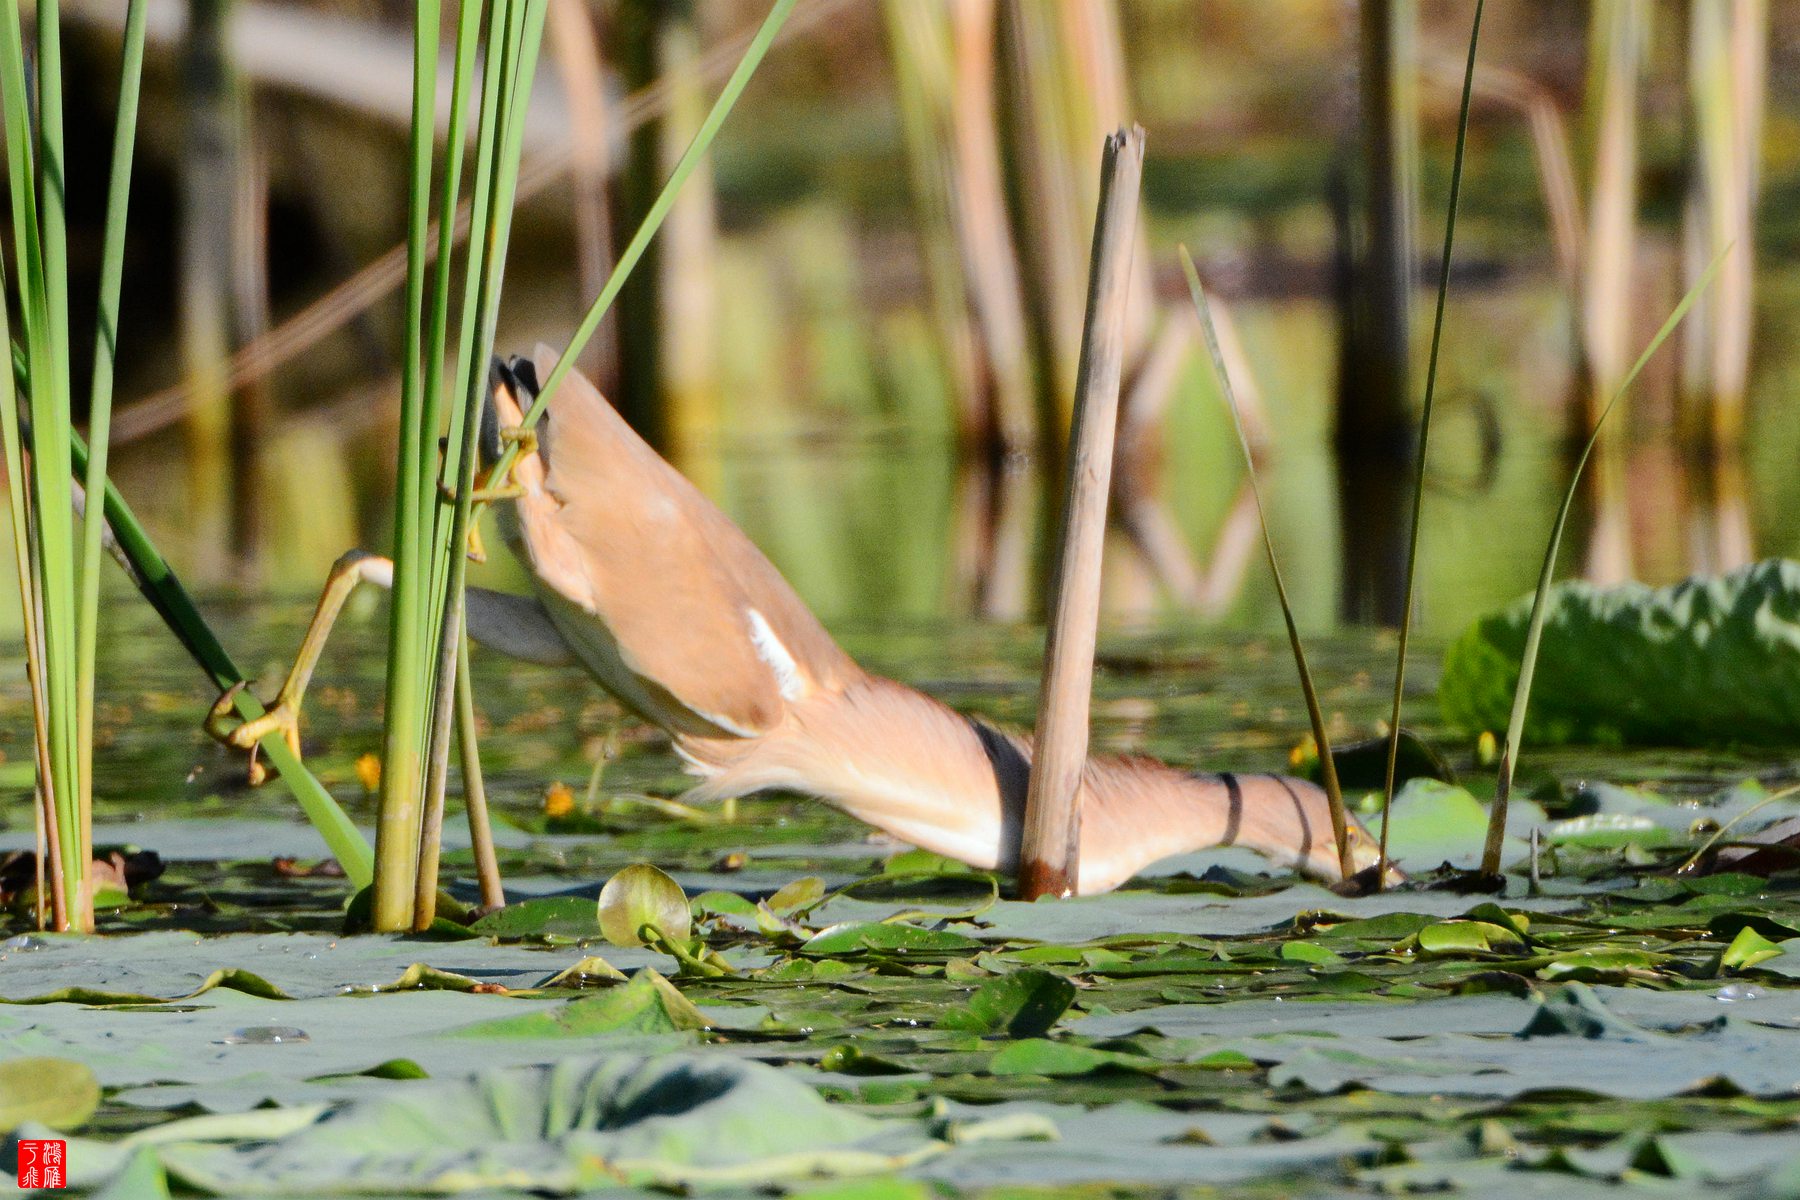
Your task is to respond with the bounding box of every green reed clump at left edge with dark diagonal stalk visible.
[0,0,371,899]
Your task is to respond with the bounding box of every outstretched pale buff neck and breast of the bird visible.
[680,676,1310,894]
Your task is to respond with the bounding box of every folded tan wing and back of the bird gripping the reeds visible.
[493,345,855,736]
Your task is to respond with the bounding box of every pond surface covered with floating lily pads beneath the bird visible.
[0,597,1800,1200]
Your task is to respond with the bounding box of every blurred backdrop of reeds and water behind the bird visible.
[24,0,1800,635]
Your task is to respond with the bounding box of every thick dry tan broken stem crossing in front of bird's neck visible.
[1019,126,1143,900]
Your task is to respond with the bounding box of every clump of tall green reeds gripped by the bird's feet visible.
[373,0,796,930]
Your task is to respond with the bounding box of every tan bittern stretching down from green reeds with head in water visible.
[209,345,1377,894]
